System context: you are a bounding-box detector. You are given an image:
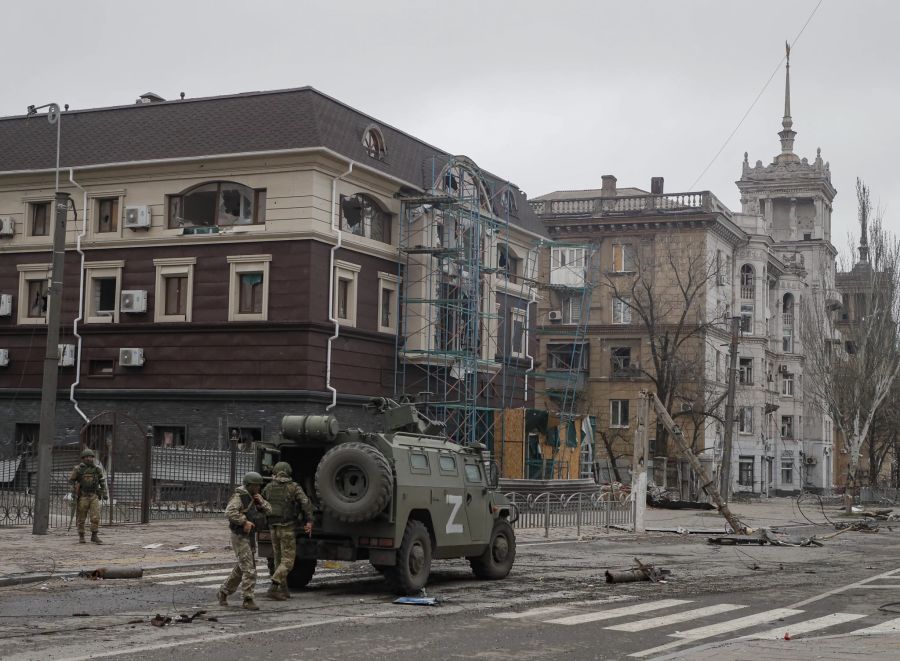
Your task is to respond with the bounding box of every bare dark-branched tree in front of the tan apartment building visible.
[602,232,722,464]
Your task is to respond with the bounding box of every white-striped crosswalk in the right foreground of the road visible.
[492,599,900,658]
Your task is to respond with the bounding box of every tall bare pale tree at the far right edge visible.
[800,180,900,509]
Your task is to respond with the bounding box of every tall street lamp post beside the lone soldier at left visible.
[28,103,69,535]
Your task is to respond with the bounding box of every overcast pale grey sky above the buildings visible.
[0,0,900,249]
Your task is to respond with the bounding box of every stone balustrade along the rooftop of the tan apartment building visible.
[529,191,731,219]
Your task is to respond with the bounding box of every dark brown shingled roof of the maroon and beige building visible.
[0,87,546,236]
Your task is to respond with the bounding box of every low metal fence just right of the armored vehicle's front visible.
[506,492,634,536]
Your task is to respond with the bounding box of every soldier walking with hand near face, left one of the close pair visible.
[218,471,272,611]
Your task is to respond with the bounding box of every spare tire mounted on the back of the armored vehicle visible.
[316,442,393,523]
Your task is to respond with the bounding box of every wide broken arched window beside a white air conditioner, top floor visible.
[168,181,266,229]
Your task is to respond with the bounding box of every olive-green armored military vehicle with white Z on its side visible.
[257,398,516,594]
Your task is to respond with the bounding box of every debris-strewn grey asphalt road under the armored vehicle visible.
[0,528,900,661]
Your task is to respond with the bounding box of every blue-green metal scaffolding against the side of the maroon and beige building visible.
[394,157,538,448]
